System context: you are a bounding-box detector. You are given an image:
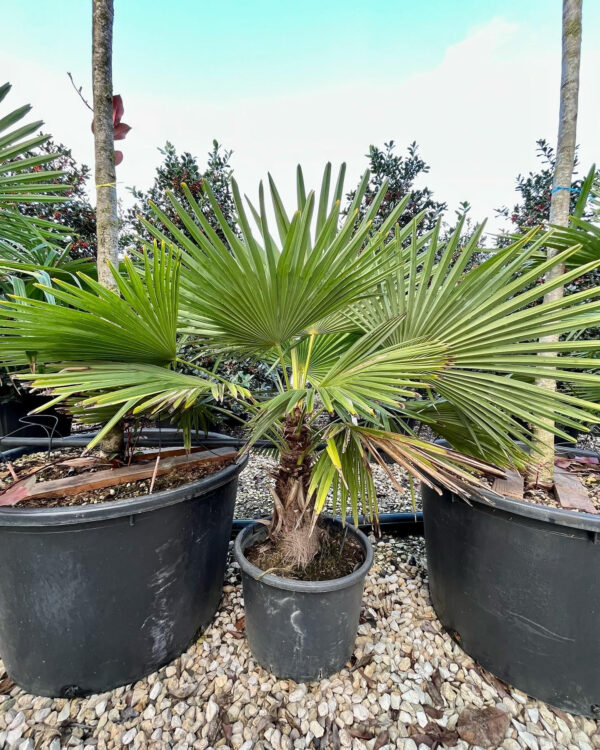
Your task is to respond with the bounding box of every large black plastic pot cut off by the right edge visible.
[422,451,600,718]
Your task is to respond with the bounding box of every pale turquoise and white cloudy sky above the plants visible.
[0,0,600,235]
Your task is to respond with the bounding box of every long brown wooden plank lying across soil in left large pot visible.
[27,448,237,497]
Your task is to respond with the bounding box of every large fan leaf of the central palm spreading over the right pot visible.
[353,220,600,465]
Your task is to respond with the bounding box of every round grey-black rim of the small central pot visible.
[233,516,374,594]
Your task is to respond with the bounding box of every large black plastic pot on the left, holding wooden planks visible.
[0,434,245,697]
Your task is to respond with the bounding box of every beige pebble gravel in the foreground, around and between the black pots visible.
[0,538,600,750]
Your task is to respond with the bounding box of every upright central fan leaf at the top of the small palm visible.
[141,165,406,355]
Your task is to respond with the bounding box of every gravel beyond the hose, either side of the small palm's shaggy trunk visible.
[235,453,421,518]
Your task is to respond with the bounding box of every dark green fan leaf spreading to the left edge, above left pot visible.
[0,250,179,365]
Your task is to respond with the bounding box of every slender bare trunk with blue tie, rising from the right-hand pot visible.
[527,0,582,487]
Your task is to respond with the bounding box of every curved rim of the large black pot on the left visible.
[0,448,248,528]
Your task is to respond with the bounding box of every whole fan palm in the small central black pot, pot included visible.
[0,165,600,692]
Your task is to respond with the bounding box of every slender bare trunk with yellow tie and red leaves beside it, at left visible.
[92,0,123,455]
